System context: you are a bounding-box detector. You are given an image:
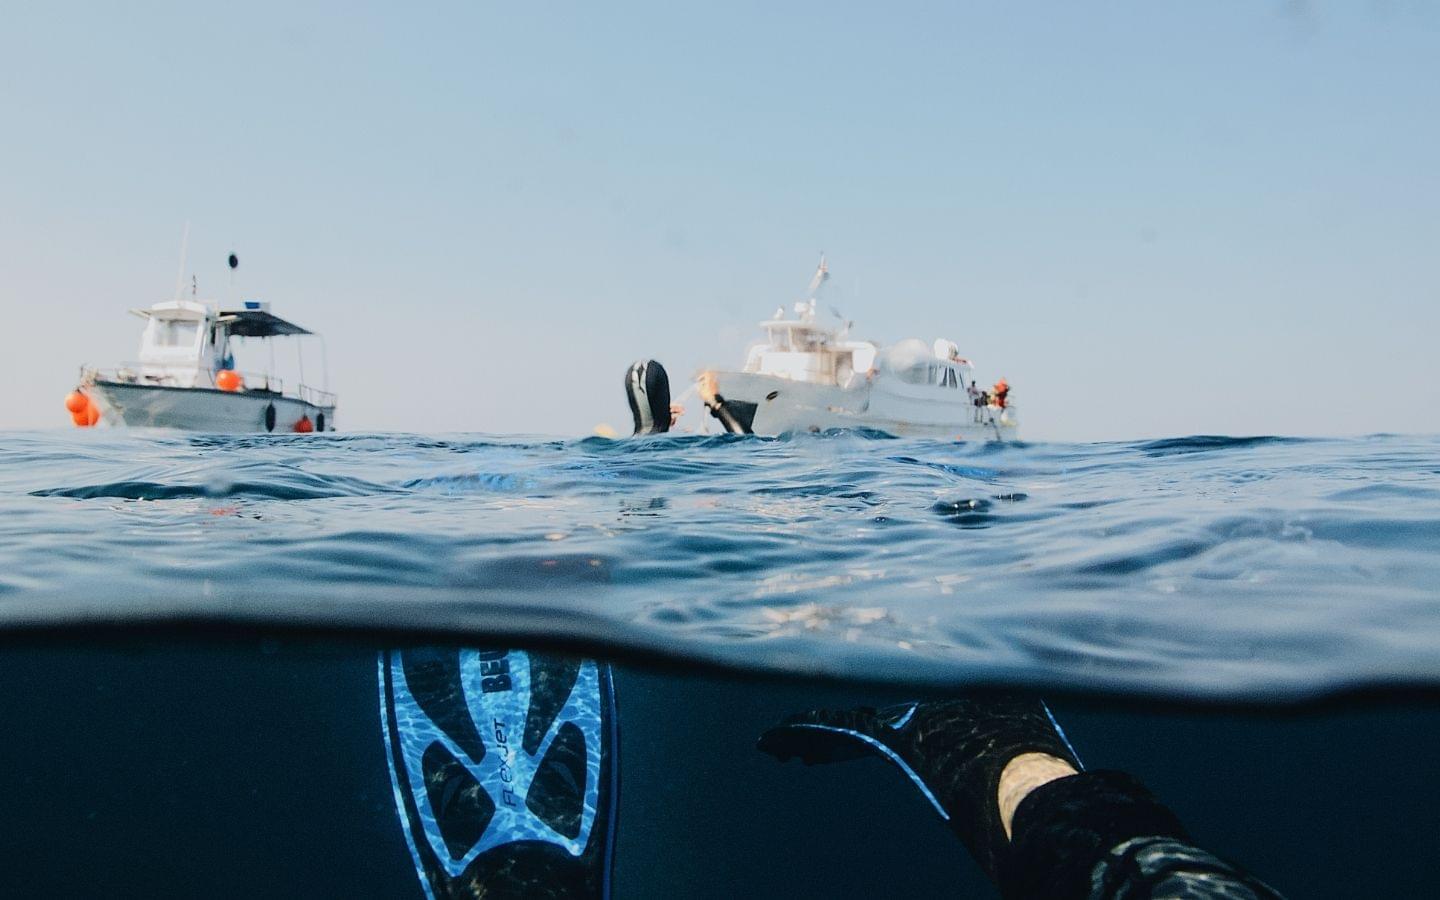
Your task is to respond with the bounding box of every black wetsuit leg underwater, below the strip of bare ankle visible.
[998,770,1280,900]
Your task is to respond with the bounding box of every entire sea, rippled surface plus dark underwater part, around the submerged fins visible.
[0,432,1440,897]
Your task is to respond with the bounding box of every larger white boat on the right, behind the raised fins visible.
[701,258,1020,441]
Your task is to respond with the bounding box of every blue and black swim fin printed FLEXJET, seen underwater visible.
[380,649,616,897]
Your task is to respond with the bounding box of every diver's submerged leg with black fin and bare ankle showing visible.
[756,694,1280,900]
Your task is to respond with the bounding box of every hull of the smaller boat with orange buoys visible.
[88,380,336,433]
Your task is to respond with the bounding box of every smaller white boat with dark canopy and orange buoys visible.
[65,286,336,432]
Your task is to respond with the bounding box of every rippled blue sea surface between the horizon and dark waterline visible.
[0,432,1440,701]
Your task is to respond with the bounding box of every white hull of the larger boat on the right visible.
[714,372,1020,441]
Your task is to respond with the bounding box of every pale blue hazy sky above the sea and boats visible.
[0,0,1440,441]
